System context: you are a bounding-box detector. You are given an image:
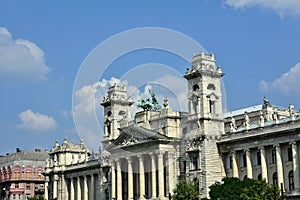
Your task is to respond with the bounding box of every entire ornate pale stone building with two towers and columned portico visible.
[46,53,300,200]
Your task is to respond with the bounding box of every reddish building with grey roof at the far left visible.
[0,148,48,200]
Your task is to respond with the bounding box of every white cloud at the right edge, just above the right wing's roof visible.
[260,63,300,96]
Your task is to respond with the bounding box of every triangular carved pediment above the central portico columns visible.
[109,125,169,147]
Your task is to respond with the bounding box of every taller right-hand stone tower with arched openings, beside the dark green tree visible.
[184,52,224,197]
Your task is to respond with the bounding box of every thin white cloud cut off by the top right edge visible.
[225,0,300,17]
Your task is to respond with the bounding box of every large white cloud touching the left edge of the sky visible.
[0,27,50,81]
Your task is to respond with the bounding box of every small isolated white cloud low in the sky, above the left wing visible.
[17,109,57,131]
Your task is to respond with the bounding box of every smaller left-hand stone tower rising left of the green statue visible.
[101,84,133,149]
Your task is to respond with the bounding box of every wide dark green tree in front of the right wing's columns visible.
[209,178,280,200]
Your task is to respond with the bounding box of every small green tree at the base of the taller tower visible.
[172,181,200,200]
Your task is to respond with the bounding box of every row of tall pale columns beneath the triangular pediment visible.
[111,151,176,200]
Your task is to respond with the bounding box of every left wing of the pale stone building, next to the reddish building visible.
[45,138,101,200]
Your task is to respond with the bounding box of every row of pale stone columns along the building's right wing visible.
[231,142,300,191]
